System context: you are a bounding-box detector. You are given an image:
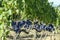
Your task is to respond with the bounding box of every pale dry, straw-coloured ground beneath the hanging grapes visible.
[7,30,60,40]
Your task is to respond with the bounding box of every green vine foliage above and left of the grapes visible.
[0,0,60,37]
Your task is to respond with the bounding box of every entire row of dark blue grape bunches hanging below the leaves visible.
[11,20,54,33]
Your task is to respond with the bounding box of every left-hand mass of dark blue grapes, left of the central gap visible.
[11,20,32,33]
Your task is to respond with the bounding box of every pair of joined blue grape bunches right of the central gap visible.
[34,22,55,32]
